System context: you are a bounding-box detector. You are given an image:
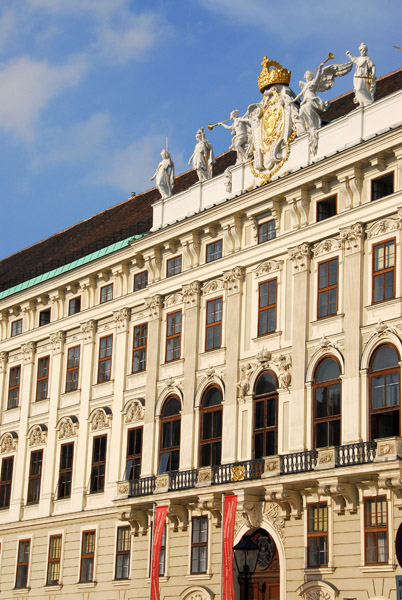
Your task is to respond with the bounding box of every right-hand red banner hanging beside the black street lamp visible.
[222,495,237,600]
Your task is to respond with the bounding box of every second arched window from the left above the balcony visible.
[199,387,222,467]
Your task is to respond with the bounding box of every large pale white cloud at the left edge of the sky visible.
[0,57,87,140]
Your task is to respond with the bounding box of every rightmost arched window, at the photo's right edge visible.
[370,345,400,440]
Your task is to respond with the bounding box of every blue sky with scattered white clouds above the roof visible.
[0,0,402,258]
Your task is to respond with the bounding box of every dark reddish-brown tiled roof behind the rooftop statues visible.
[0,69,402,291]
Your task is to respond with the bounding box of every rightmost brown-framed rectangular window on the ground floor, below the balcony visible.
[364,496,388,565]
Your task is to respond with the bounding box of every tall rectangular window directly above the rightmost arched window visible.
[373,240,395,304]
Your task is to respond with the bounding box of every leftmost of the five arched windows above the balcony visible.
[158,396,181,473]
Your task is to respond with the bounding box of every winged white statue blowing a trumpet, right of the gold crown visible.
[293,55,352,154]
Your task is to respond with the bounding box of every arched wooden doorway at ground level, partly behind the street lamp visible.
[239,529,280,600]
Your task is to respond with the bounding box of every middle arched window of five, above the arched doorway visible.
[253,371,278,458]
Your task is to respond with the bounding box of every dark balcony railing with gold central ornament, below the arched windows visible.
[129,441,377,497]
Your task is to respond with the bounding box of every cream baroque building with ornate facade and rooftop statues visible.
[0,57,402,600]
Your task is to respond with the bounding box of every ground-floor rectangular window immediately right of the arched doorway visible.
[307,504,328,567]
